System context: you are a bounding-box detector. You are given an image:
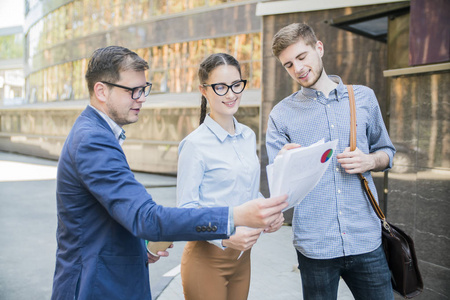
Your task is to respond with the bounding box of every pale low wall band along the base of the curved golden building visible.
[0,90,260,175]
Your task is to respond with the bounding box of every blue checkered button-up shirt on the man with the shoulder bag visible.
[266,76,395,259]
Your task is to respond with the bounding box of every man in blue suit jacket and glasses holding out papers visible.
[52,46,287,300]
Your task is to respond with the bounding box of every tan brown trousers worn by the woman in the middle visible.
[181,241,251,300]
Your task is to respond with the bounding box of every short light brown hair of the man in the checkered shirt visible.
[272,23,317,57]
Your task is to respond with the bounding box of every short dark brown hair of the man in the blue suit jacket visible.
[85,46,149,95]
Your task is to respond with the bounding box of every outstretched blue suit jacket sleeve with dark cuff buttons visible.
[72,127,228,241]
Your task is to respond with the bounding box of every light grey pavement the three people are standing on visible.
[0,152,354,300]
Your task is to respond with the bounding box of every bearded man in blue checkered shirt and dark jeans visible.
[266,23,395,300]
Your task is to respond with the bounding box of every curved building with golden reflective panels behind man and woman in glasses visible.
[0,0,262,174]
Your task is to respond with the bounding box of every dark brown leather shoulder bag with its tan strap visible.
[347,85,423,299]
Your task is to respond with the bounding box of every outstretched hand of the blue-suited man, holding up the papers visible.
[233,195,288,228]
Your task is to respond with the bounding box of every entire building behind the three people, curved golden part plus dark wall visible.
[0,0,450,300]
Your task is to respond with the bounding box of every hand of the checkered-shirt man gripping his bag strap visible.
[336,147,389,174]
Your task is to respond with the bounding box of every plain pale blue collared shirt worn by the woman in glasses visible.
[177,115,260,247]
